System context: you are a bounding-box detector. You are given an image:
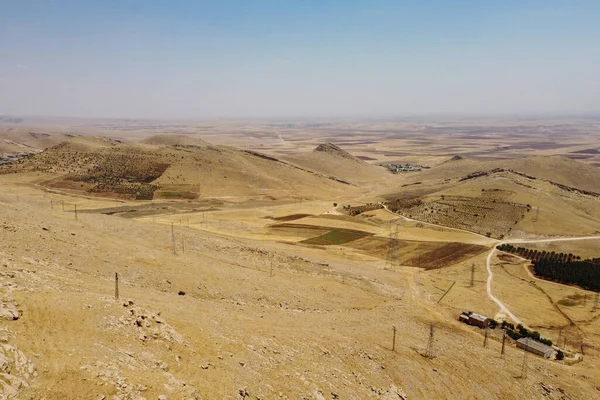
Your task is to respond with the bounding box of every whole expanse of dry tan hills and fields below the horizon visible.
[0,119,600,399]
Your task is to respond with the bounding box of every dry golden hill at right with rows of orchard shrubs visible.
[382,157,600,238]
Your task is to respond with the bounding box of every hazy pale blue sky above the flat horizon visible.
[0,0,600,118]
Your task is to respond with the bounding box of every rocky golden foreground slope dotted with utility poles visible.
[0,178,600,399]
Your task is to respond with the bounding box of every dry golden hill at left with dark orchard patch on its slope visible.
[3,137,359,200]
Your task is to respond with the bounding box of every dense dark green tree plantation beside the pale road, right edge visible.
[497,244,600,291]
